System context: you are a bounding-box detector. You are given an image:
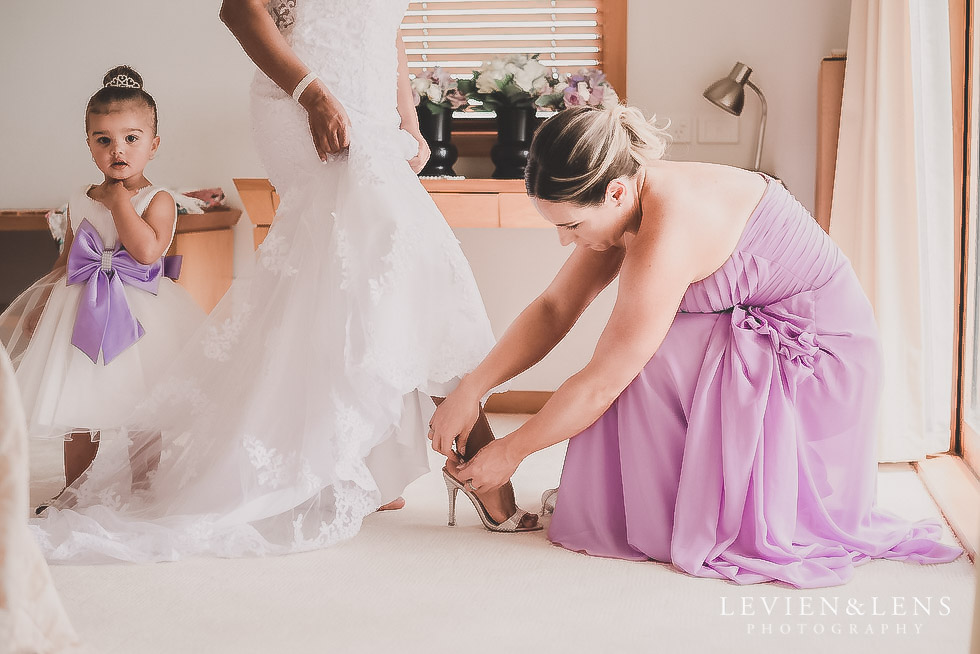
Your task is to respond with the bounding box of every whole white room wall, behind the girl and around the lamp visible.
[0,0,849,390]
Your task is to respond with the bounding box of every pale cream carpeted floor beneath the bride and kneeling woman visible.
[26,416,975,654]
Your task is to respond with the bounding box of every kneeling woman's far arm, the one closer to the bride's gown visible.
[432,247,623,456]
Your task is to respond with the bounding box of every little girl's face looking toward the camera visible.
[88,102,160,181]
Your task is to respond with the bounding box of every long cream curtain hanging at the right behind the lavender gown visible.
[830,0,954,461]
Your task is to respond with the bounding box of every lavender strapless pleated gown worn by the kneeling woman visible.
[548,180,961,588]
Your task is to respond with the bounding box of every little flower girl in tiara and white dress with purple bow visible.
[0,66,203,510]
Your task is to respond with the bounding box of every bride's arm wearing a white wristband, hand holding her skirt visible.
[219,0,350,160]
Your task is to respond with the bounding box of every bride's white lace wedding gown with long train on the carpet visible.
[32,0,494,563]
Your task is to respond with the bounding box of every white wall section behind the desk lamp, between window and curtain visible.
[627,0,851,210]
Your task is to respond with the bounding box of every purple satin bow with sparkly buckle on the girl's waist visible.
[68,220,181,365]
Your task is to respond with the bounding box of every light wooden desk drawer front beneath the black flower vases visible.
[234,178,554,247]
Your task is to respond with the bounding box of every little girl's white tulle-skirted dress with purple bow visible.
[0,186,204,444]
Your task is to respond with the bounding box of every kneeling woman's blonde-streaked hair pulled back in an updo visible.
[524,105,669,206]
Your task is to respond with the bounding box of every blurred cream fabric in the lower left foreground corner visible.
[0,348,88,654]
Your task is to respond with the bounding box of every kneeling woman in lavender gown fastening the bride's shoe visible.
[433,107,961,587]
